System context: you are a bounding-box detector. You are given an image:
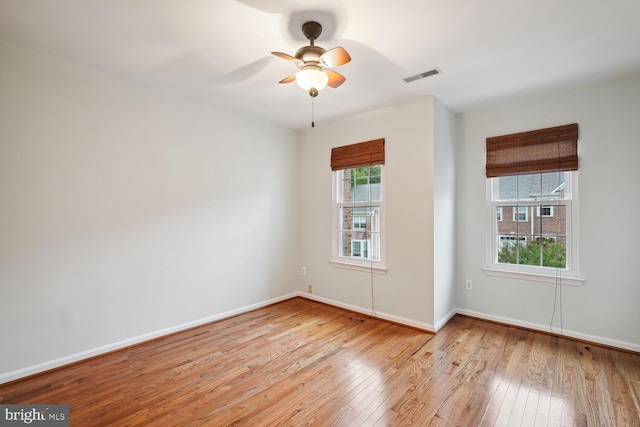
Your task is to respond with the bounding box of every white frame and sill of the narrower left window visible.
[329,165,387,274]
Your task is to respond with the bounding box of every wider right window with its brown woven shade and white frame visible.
[485,125,580,284]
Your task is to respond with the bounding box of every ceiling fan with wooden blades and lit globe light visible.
[271,21,351,98]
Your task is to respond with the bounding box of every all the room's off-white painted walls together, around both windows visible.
[0,36,640,382]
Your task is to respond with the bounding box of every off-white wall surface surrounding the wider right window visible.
[456,75,640,350]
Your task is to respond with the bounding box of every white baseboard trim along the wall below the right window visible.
[456,308,640,353]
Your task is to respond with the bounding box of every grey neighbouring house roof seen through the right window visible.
[498,172,564,200]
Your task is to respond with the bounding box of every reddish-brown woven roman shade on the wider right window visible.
[486,123,578,178]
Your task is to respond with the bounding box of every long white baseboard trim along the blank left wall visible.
[0,293,298,384]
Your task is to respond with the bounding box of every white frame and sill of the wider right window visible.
[482,172,584,286]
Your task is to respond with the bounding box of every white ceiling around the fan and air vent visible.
[0,0,640,128]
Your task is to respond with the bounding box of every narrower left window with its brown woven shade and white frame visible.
[331,139,386,273]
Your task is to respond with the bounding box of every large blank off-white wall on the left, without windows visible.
[0,42,300,379]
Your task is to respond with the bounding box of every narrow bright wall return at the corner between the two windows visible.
[433,99,456,329]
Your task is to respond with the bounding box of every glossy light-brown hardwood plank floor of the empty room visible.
[0,298,640,426]
